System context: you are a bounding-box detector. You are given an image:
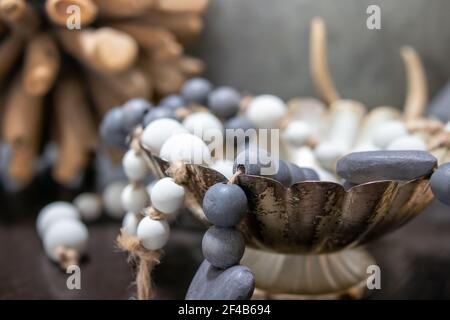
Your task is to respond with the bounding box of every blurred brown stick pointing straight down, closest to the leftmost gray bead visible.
[53,78,97,185]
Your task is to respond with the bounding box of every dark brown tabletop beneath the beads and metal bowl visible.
[0,174,450,299]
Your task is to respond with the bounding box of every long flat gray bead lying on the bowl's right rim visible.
[336,150,437,184]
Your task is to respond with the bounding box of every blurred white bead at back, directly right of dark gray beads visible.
[246,94,287,129]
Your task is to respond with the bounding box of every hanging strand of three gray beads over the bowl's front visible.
[186,171,255,300]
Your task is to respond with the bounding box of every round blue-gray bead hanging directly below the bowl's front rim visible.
[203,183,247,227]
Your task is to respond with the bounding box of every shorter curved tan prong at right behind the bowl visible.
[401,47,428,121]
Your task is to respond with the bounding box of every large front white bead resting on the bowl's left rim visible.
[159,133,211,164]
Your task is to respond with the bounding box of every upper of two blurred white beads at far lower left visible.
[36,201,80,237]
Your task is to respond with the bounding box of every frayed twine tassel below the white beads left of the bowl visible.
[117,230,163,300]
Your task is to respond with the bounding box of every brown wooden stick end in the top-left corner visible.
[0,0,40,37]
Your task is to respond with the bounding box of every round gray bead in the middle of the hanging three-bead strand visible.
[202,227,245,269]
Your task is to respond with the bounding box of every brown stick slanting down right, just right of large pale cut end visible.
[111,22,183,60]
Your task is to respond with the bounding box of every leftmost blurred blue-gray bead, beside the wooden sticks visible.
[100,107,128,147]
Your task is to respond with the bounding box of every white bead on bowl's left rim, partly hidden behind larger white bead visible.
[141,118,188,155]
